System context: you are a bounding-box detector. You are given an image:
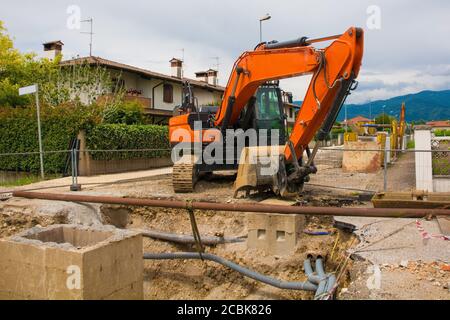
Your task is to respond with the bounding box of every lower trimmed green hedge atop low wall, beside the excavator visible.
[86,124,170,160]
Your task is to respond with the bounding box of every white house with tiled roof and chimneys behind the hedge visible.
[44,41,225,124]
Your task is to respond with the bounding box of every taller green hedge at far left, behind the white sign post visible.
[0,106,94,173]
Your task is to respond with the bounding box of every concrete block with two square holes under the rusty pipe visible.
[247,213,305,255]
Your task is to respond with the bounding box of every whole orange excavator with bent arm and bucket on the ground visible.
[169,27,363,195]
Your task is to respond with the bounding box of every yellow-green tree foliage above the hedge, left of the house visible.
[0,21,123,107]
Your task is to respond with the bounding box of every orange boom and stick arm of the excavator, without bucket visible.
[215,27,363,161]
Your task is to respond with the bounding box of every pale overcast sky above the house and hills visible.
[0,0,450,103]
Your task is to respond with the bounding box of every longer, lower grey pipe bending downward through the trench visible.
[144,252,317,291]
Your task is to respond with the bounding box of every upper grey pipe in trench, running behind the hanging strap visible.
[141,229,245,246]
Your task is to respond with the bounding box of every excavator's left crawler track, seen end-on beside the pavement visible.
[172,155,198,193]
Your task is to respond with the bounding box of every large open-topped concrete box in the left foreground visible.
[0,225,143,299]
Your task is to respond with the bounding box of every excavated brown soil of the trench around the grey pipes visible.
[99,202,355,299]
